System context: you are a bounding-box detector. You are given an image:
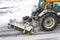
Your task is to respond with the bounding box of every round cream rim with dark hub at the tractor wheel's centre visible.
[44,17,55,29]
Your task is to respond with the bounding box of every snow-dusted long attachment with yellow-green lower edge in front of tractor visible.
[8,21,32,35]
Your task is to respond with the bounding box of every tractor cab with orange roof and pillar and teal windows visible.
[38,0,60,12]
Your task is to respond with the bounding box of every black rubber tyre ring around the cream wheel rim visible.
[39,13,57,31]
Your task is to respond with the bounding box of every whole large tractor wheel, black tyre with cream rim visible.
[39,13,57,31]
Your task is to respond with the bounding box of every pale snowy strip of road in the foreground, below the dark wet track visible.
[0,30,60,40]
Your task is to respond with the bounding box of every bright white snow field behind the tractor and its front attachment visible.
[0,0,39,27]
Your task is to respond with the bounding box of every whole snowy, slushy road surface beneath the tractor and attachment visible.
[0,24,60,40]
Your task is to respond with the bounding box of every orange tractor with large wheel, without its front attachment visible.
[32,0,60,31]
